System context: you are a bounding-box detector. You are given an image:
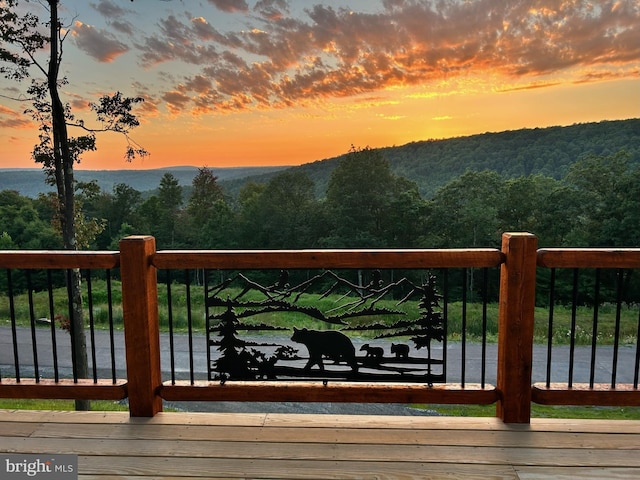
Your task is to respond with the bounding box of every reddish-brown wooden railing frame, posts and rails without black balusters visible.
[0,233,640,423]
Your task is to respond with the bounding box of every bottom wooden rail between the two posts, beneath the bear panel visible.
[160,381,498,405]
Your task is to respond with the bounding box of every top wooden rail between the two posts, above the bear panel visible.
[152,248,504,269]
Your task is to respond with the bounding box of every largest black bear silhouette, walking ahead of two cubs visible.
[291,327,358,372]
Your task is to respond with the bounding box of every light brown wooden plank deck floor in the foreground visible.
[0,410,640,480]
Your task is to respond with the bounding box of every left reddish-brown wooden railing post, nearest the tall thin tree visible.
[120,236,162,417]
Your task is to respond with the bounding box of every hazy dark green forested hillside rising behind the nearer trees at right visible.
[221,119,640,198]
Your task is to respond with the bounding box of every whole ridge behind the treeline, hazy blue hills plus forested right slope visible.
[0,118,640,198]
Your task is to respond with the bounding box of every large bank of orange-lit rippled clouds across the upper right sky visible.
[127,0,640,113]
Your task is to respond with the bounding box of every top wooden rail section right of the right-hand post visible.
[537,248,640,268]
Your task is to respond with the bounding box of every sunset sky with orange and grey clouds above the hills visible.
[0,0,640,169]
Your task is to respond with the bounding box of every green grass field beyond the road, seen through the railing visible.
[0,280,638,345]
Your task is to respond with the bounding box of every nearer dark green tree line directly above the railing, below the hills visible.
[0,148,640,250]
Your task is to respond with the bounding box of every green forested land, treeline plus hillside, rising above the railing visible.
[0,120,640,262]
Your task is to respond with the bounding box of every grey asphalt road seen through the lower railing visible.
[0,326,636,415]
